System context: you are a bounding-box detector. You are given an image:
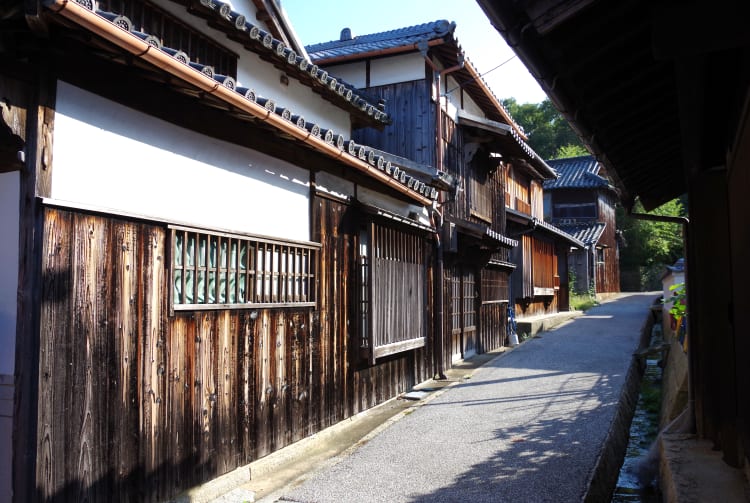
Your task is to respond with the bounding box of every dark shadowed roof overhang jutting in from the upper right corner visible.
[477,0,750,209]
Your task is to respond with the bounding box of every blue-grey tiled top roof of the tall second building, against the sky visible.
[305,20,456,61]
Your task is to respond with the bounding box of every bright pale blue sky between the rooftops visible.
[280,0,546,103]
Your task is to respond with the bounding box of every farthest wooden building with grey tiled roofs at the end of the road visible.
[544,156,620,298]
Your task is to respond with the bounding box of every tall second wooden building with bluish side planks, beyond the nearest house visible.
[307,20,575,365]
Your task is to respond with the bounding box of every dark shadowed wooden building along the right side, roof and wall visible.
[479,0,750,485]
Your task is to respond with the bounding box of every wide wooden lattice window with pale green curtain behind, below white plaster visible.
[171,226,319,309]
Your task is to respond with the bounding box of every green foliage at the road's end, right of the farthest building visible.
[617,199,686,290]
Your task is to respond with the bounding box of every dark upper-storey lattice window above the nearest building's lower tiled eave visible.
[98,0,238,78]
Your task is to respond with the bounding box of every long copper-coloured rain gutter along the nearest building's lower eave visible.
[43,0,432,206]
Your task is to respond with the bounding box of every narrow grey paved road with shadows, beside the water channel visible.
[274,294,656,503]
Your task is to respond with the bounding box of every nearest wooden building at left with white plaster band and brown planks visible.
[0,0,450,502]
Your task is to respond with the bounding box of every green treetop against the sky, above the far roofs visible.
[503,98,588,159]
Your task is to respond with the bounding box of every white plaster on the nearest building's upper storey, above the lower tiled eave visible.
[155,0,351,138]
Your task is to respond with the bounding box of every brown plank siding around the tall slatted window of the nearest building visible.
[312,196,434,426]
